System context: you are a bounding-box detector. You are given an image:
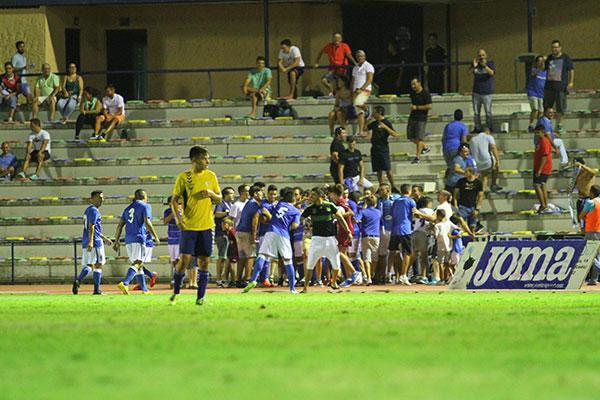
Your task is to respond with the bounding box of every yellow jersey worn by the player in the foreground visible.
[173,169,221,231]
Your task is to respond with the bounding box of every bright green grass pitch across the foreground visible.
[0,292,600,400]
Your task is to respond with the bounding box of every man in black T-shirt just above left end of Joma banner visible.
[453,166,483,231]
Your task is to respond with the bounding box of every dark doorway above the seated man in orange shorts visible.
[106,29,147,100]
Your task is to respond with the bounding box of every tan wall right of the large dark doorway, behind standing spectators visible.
[424,0,600,93]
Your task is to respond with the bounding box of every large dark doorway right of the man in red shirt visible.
[342,2,423,94]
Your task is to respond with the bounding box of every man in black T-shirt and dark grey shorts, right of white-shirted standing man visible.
[406,77,433,164]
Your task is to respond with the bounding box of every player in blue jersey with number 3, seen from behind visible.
[113,189,160,294]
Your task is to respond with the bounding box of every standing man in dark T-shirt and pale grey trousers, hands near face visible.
[469,49,496,133]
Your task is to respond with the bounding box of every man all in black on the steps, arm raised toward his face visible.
[369,106,400,187]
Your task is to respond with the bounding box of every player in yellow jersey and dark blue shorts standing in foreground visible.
[169,146,223,305]
